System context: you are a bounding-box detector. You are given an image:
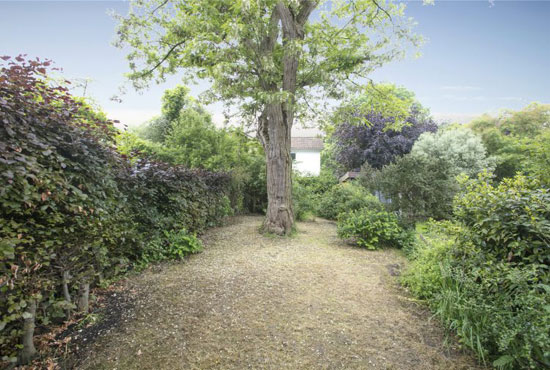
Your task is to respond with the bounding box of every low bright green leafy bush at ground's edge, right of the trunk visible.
[338,208,409,250]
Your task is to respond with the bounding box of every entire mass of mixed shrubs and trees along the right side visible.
[319,86,550,369]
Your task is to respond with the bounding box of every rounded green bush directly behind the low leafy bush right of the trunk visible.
[317,183,384,220]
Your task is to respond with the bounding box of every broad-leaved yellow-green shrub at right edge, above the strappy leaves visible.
[455,173,550,268]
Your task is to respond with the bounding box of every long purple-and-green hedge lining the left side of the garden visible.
[0,56,232,365]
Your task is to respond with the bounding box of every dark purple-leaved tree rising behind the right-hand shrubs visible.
[330,86,437,172]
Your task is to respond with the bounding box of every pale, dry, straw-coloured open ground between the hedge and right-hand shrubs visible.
[80,216,484,370]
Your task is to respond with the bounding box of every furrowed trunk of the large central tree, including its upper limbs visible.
[258,0,319,235]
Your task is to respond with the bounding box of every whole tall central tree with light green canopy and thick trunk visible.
[116,0,419,235]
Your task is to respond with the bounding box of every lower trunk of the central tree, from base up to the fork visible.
[258,104,294,235]
